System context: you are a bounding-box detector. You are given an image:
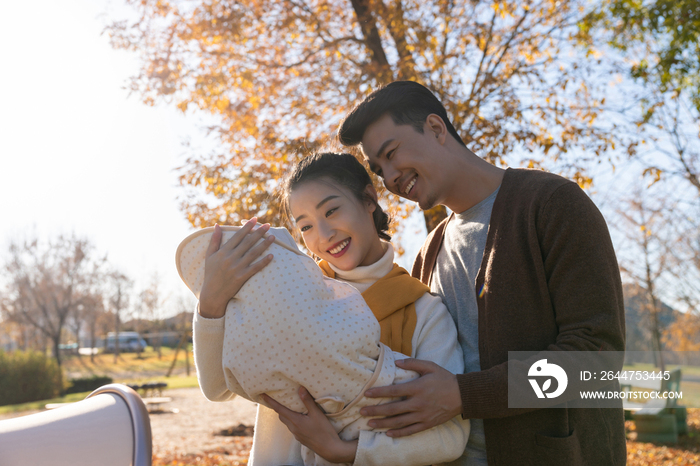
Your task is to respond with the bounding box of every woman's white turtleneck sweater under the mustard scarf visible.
[193,243,469,466]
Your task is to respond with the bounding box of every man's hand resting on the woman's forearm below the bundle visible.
[360,359,462,437]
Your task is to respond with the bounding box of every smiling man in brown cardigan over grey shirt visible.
[338,81,626,466]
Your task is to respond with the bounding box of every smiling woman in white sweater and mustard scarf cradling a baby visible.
[194,153,469,466]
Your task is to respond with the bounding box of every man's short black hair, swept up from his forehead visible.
[338,81,465,146]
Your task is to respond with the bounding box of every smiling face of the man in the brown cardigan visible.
[362,114,442,210]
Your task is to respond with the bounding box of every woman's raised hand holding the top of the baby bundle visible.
[199,218,275,319]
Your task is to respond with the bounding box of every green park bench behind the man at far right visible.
[620,368,688,443]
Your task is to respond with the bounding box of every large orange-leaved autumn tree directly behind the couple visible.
[106,0,614,235]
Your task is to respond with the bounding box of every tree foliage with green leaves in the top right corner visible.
[581,0,700,197]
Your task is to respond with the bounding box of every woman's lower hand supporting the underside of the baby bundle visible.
[262,387,357,463]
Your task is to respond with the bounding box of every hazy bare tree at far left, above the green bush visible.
[0,235,104,384]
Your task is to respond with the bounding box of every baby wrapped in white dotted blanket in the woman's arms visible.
[176,227,417,465]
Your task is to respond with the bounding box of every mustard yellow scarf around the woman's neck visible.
[318,260,430,356]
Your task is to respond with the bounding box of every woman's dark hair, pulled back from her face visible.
[280,152,391,241]
